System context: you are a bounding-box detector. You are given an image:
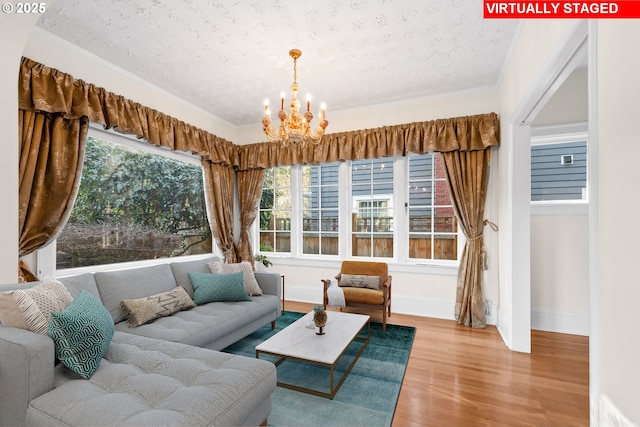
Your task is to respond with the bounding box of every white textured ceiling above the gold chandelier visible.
[38,0,517,125]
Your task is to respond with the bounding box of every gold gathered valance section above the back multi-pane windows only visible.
[237,113,500,170]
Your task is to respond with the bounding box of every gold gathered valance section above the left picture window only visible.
[18,58,237,166]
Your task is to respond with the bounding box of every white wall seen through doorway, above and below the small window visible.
[531,67,589,335]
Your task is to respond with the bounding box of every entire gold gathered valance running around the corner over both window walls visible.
[19,58,500,171]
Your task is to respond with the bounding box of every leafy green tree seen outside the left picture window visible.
[69,138,208,233]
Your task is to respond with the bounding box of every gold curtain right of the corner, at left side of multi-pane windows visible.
[236,169,264,263]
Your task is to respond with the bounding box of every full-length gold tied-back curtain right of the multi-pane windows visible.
[441,148,491,328]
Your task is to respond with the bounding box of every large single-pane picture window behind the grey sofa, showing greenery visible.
[56,137,211,269]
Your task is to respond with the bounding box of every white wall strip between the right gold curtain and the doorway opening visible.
[498,20,579,352]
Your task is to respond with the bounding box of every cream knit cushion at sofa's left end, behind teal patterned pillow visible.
[0,279,73,335]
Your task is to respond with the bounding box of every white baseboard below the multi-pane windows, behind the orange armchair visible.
[285,286,498,325]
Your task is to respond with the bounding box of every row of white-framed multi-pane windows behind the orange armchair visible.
[255,154,464,266]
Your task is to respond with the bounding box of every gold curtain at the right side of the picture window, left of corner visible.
[202,160,236,263]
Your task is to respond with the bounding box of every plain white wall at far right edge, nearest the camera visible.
[591,19,640,425]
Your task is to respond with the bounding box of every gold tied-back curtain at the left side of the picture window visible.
[18,110,89,279]
